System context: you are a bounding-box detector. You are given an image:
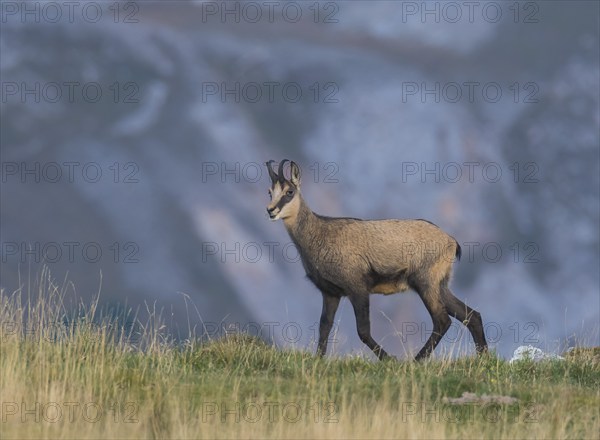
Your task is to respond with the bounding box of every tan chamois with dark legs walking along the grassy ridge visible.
[266,159,487,360]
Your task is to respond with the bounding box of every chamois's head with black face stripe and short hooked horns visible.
[267,159,300,221]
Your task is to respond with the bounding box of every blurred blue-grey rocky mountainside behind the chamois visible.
[0,2,600,356]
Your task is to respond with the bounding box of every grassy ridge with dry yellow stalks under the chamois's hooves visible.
[0,274,600,439]
